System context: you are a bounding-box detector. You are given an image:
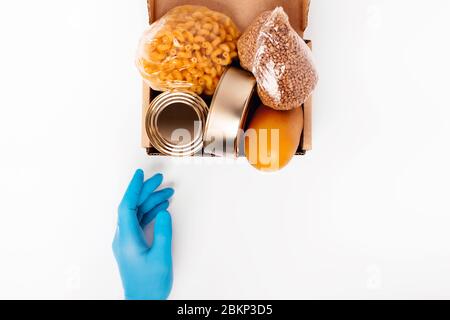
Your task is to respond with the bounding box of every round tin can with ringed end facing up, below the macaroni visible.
[145,91,208,157]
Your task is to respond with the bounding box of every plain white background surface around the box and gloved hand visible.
[0,0,450,299]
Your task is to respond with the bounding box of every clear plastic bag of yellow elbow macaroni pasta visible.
[136,6,240,95]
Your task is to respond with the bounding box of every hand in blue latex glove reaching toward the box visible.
[113,170,174,300]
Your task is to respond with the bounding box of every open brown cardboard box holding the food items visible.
[142,0,312,156]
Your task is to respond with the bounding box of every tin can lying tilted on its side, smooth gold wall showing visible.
[204,67,256,157]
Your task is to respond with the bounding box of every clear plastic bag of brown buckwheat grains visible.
[238,7,318,110]
